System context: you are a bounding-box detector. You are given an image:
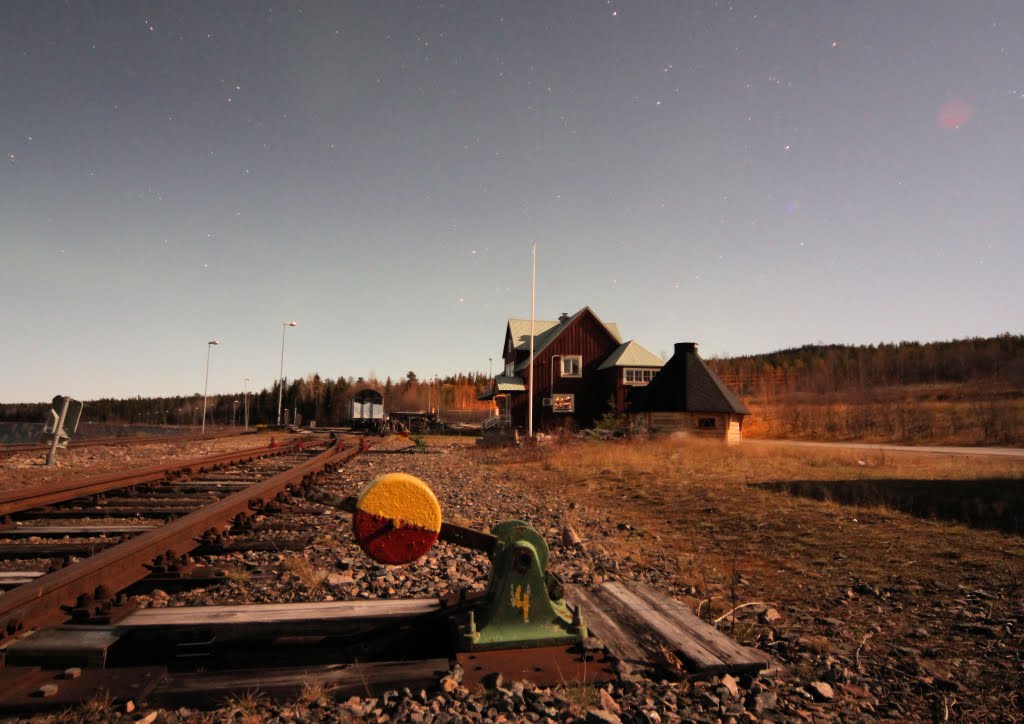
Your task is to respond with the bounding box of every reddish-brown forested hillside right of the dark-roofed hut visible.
[707,334,1024,445]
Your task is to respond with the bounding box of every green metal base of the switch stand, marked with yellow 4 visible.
[457,520,587,651]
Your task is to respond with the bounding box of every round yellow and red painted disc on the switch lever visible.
[352,473,441,565]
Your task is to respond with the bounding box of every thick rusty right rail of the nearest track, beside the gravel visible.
[0,438,359,636]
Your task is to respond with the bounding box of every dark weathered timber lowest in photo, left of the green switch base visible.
[146,658,451,707]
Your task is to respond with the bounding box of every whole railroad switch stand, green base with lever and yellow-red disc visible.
[343,473,587,652]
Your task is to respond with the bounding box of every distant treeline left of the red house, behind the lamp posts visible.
[0,372,490,426]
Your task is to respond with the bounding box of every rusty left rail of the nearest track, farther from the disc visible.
[0,440,297,515]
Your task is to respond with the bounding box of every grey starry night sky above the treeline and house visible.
[0,0,1024,402]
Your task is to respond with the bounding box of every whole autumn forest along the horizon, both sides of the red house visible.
[0,334,1024,444]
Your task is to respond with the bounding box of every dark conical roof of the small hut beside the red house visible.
[630,342,751,415]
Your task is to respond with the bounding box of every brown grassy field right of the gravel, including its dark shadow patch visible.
[487,439,1024,718]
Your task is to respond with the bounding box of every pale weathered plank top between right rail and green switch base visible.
[118,598,441,629]
